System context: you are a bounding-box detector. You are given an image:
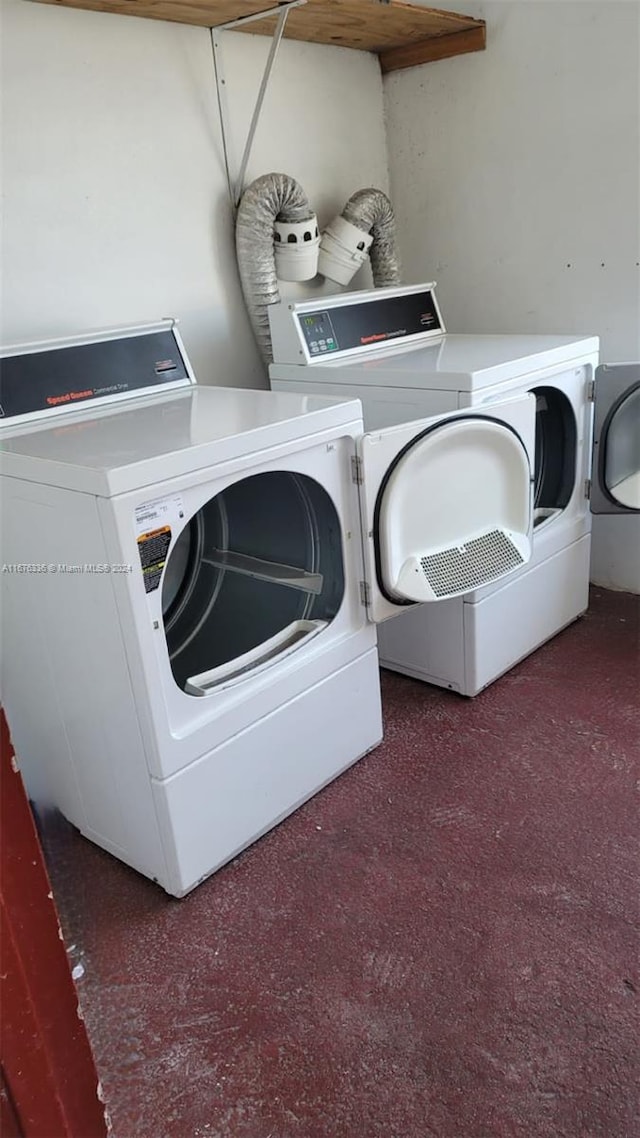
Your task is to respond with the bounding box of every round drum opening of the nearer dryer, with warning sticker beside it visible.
[162,471,344,696]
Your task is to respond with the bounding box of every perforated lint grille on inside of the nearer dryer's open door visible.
[420,529,524,596]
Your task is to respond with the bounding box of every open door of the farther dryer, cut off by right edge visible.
[591,363,640,513]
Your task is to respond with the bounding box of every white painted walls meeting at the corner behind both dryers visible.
[0,0,640,591]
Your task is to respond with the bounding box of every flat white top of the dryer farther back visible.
[277,332,599,390]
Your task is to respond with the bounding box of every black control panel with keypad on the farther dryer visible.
[300,289,442,357]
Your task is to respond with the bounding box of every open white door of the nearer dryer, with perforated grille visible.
[359,394,535,621]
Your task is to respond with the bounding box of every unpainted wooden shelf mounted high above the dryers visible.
[29,0,485,72]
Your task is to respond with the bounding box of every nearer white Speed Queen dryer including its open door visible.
[0,322,535,896]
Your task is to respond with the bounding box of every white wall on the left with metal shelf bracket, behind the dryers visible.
[0,0,388,387]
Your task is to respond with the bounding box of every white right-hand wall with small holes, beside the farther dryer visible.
[385,0,640,592]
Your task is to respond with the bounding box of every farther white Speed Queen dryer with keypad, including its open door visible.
[269,285,640,695]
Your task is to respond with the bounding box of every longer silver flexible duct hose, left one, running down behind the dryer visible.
[236,174,313,363]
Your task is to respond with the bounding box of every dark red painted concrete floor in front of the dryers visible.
[42,589,640,1138]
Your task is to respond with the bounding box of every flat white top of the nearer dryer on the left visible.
[0,386,362,496]
